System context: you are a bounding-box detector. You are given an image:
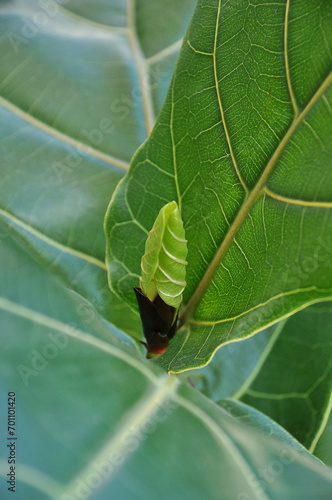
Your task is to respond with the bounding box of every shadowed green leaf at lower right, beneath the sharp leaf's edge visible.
[184,303,332,451]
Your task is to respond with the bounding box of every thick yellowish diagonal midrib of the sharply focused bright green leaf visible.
[180,73,332,325]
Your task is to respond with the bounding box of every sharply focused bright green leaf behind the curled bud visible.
[106,0,332,372]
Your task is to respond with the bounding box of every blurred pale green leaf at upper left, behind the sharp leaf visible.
[0,0,194,337]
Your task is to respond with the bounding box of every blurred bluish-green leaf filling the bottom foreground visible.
[0,228,332,500]
